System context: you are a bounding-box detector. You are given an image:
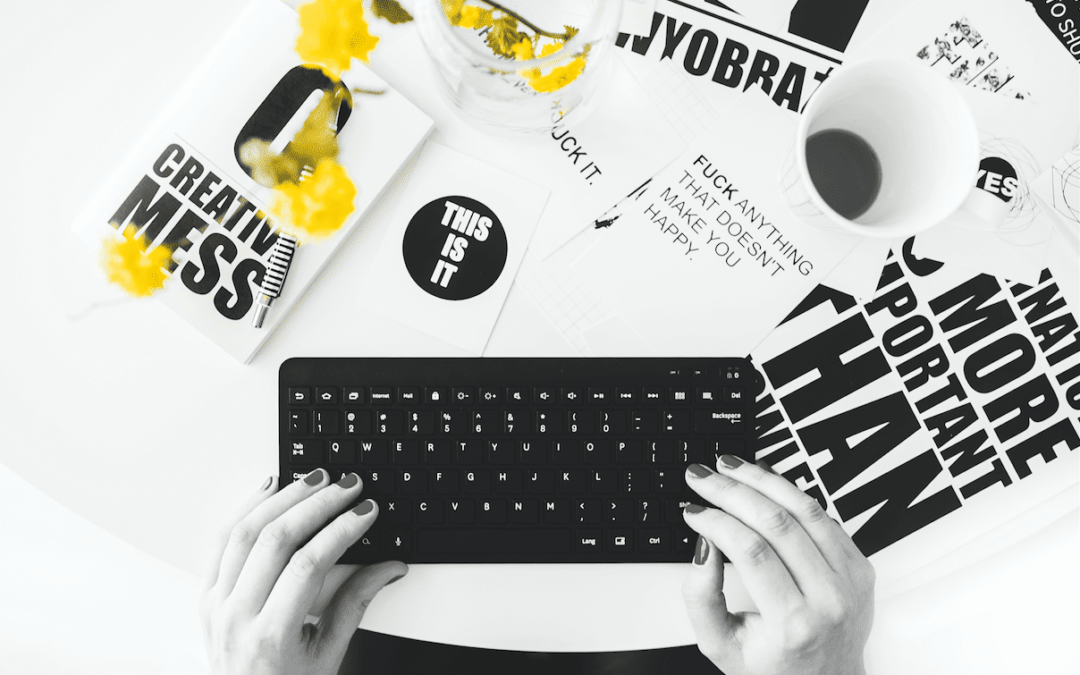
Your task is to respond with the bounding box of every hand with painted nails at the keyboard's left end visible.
[200,469,408,675]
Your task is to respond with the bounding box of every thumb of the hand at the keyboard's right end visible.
[683,535,741,670]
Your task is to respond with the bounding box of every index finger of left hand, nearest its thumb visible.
[262,488,378,635]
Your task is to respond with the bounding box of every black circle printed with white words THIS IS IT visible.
[402,197,507,300]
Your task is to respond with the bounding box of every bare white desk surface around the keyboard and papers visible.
[0,0,1080,673]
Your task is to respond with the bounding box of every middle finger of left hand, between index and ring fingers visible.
[229,470,361,615]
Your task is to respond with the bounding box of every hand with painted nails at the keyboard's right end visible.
[683,455,875,675]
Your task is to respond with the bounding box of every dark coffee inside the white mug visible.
[806,129,881,220]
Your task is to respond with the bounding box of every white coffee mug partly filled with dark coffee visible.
[781,58,980,238]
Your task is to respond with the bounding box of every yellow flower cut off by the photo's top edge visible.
[296,0,379,75]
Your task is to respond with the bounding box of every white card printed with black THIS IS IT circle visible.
[359,141,548,355]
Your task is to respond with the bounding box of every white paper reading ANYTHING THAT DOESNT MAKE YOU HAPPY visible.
[573,93,860,355]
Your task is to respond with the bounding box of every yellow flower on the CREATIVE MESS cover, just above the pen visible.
[270,158,356,241]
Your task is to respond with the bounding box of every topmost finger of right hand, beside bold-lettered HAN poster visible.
[716,455,864,573]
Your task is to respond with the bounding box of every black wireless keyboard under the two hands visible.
[279,359,754,564]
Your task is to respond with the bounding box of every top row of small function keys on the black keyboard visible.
[288,387,743,405]
